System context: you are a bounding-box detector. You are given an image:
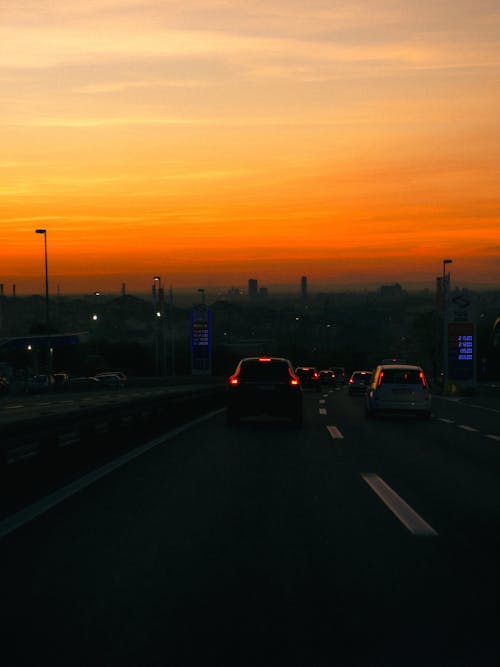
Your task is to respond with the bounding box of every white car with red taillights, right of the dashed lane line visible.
[365,363,431,419]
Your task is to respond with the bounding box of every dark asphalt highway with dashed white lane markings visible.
[0,388,500,667]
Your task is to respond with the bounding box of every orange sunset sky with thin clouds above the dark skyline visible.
[0,0,500,293]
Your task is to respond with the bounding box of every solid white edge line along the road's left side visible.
[0,408,224,540]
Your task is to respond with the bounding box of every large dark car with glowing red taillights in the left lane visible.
[226,357,302,427]
